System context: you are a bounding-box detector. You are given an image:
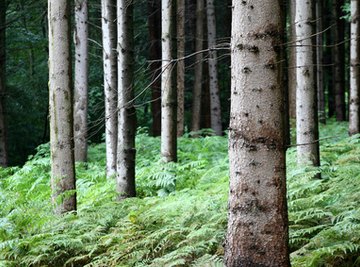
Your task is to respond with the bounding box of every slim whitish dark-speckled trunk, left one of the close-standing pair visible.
[101,0,118,177]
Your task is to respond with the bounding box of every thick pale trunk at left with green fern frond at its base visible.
[48,0,76,214]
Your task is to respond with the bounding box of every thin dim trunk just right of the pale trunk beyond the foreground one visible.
[316,0,326,124]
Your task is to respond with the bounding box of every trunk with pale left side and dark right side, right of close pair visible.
[116,0,136,199]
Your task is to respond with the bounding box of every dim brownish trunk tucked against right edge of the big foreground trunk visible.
[288,0,296,119]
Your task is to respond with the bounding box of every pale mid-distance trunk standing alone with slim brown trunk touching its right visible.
[161,0,177,162]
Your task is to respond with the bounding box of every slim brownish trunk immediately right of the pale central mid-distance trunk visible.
[176,0,185,136]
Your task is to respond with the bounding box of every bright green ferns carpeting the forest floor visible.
[0,122,360,267]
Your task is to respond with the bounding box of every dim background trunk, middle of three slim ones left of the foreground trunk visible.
[191,0,204,132]
